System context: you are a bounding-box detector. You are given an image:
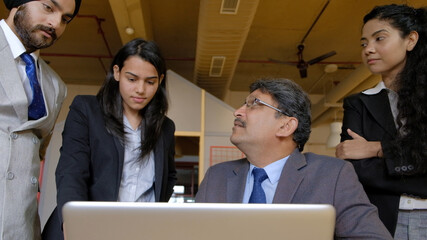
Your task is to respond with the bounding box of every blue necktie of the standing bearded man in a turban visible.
[21,53,46,120]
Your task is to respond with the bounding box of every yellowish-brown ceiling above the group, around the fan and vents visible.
[0,0,427,124]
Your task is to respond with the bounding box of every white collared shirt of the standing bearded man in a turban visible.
[0,19,40,105]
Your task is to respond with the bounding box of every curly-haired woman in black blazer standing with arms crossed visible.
[336,4,427,239]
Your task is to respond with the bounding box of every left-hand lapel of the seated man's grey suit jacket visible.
[227,159,249,203]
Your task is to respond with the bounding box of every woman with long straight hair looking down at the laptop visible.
[43,39,176,240]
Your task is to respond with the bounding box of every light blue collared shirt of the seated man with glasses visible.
[243,156,289,203]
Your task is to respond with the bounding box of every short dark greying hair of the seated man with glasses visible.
[249,78,311,152]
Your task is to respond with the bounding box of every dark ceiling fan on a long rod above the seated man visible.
[269,0,337,78]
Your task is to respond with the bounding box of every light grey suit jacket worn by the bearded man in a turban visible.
[0,28,67,240]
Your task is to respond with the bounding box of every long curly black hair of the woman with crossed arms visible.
[363,4,427,175]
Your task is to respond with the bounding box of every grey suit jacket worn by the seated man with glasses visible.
[196,149,391,239]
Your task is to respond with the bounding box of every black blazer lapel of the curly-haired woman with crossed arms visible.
[361,90,396,136]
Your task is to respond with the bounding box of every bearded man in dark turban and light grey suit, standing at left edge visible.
[0,0,81,240]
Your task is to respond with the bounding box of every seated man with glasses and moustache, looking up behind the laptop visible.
[196,79,392,239]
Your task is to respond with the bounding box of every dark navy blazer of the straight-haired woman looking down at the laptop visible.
[43,96,176,240]
